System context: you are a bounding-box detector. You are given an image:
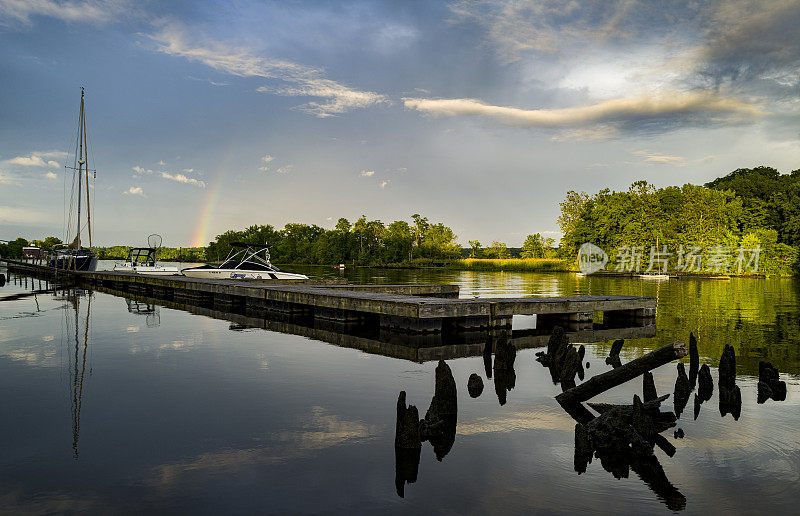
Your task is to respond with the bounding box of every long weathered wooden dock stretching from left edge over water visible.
[1,260,656,334]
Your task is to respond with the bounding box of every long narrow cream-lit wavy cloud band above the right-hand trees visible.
[403,91,764,134]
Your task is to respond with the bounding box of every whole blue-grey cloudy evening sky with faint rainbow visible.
[0,0,800,247]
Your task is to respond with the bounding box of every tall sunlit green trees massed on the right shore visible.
[558,167,800,274]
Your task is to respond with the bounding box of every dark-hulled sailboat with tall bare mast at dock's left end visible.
[48,88,97,271]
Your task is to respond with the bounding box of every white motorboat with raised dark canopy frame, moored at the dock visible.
[181,242,308,280]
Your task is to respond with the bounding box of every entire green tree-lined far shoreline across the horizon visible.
[0,167,800,275]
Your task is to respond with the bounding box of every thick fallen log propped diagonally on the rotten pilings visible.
[556,340,688,406]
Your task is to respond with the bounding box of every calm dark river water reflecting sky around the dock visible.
[0,268,800,514]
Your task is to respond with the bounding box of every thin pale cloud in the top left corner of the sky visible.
[0,0,128,25]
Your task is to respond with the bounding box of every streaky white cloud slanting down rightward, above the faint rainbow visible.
[149,24,388,118]
